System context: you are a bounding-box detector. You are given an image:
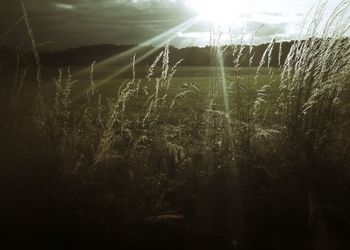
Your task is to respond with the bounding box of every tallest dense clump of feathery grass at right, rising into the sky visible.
[279,1,350,165]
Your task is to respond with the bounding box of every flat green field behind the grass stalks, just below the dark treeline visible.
[3,66,281,114]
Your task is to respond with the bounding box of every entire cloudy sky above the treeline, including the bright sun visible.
[0,0,350,50]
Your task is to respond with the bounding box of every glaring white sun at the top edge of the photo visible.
[186,0,251,24]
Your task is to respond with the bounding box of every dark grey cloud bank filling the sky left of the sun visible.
[0,0,193,49]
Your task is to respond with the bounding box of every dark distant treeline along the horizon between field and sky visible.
[0,38,349,67]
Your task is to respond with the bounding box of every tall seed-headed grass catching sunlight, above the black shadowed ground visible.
[2,0,350,245]
